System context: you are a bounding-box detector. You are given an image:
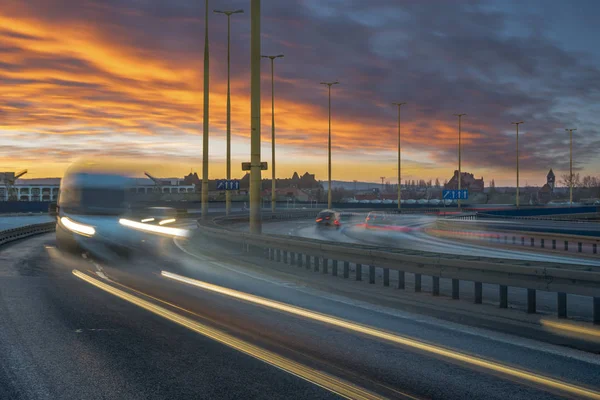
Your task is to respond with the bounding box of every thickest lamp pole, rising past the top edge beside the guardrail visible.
[250,0,262,233]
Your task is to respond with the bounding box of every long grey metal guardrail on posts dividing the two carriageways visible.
[198,215,600,324]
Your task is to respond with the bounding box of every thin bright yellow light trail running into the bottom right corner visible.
[161,271,600,400]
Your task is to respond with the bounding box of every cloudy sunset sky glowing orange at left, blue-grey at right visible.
[0,0,600,186]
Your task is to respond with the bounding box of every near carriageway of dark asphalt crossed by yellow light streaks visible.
[0,225,600,399]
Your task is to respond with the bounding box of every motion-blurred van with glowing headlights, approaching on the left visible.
[56,164,187,259]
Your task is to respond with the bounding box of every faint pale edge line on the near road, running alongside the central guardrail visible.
[174,239,600,365]
